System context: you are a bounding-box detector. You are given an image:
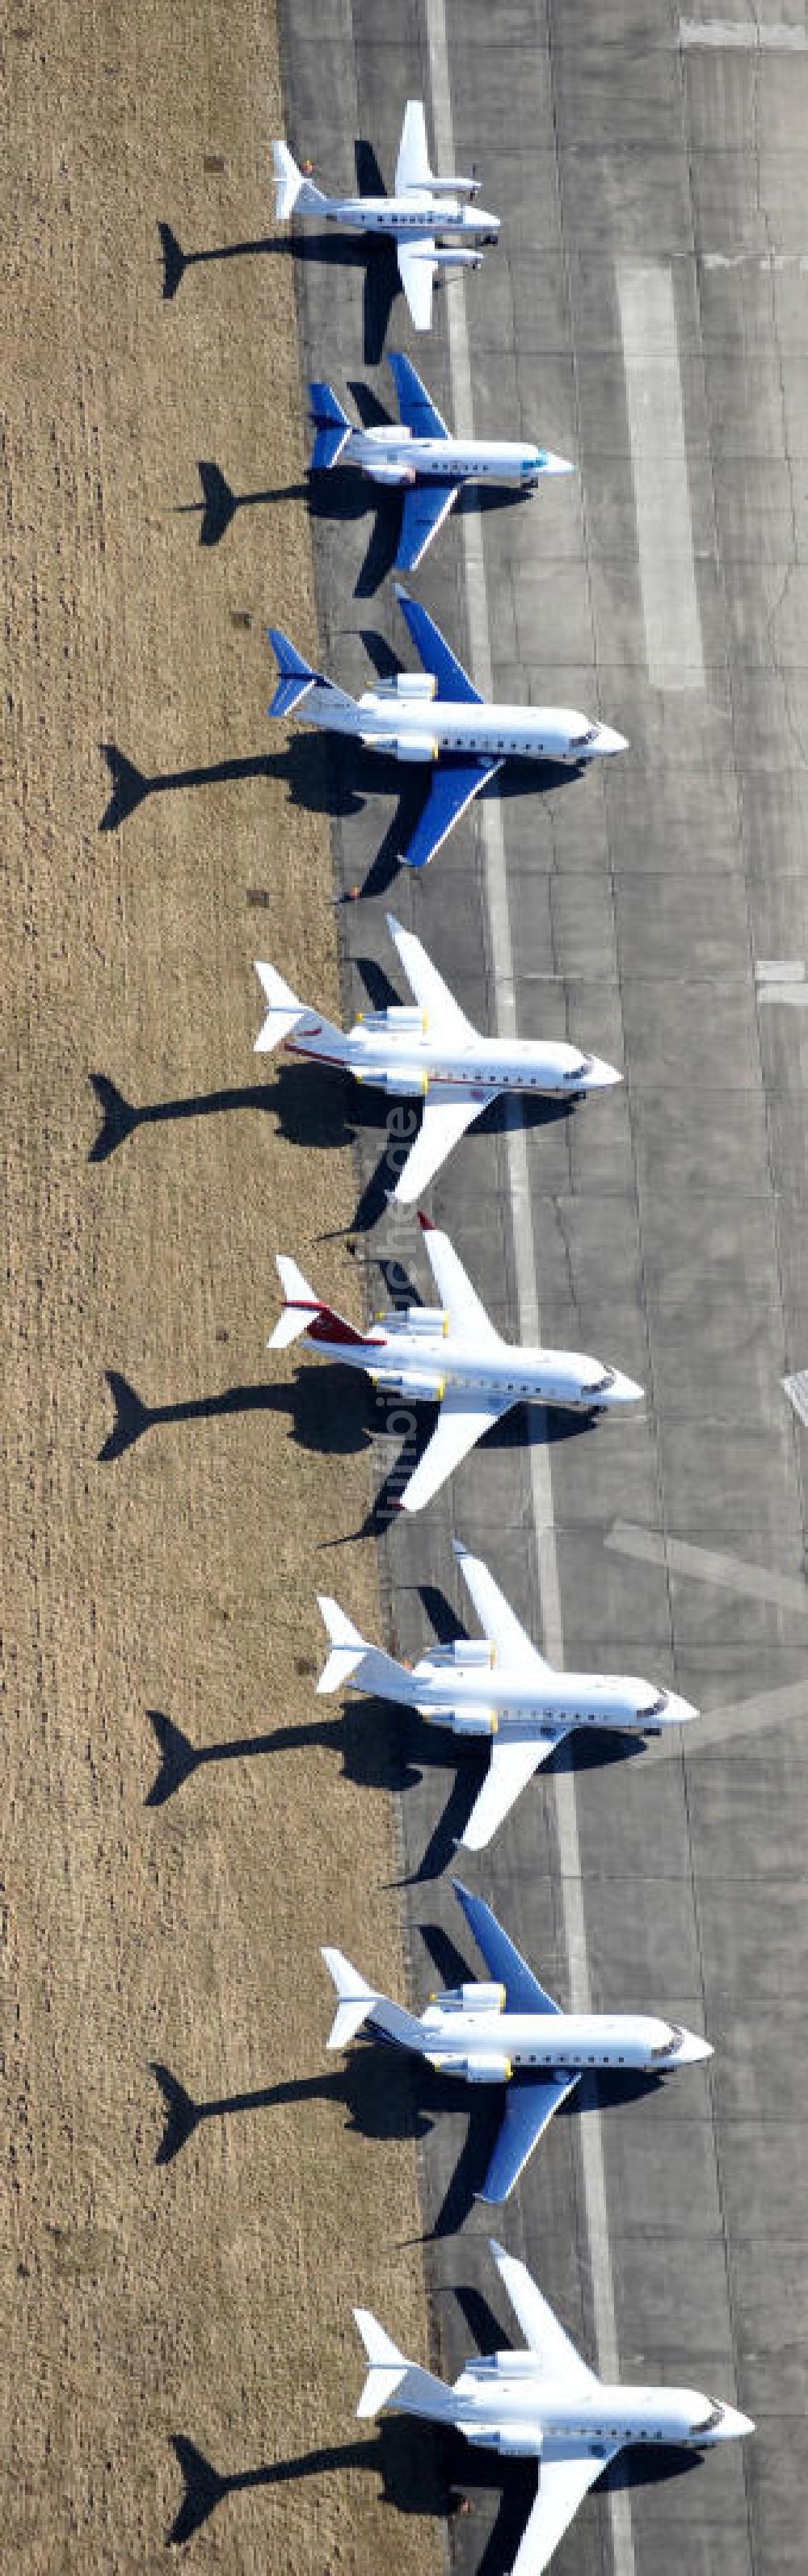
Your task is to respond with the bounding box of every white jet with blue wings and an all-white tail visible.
[322,1878,713,2202]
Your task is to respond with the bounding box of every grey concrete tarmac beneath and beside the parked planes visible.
[273,0,808,2576]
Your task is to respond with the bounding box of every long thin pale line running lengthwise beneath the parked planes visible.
[423,15,635,2576]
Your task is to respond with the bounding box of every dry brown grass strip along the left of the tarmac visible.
[0,0,441,2576]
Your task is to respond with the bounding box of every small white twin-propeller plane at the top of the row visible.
[271,98,499,329]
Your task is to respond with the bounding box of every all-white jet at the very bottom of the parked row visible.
[354,2241,754,2576]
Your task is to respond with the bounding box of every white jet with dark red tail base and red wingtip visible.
[266,1210,643,1512]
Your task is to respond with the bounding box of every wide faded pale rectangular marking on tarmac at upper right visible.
[617,260,705,688]
